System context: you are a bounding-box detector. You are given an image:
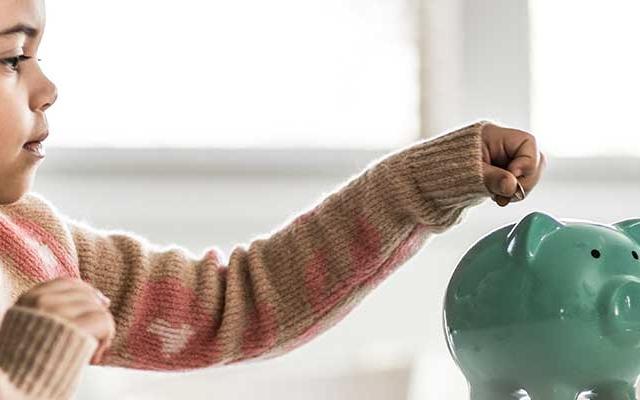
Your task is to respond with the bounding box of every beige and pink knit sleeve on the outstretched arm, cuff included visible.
[63,121,488,370]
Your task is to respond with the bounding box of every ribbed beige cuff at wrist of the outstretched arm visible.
[380,121,491,232]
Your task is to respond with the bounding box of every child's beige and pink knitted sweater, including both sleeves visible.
[0,121,489,399]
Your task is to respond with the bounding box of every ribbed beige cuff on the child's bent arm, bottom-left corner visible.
[0,305,98,399]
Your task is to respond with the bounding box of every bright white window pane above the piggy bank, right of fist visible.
[529,0,640,157]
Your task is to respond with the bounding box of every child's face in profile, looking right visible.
[0,0,57,205]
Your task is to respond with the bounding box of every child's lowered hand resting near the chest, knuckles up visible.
[16,278,115,364]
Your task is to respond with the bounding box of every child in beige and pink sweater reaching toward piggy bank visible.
[0,0,545,399]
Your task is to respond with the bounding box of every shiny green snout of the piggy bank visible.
[601,277,640,347]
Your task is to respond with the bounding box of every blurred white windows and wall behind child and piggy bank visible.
[34,0,640,400]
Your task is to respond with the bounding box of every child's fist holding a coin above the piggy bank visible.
[482,124,546,207]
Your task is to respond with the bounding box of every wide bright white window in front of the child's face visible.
[39,0,420,148]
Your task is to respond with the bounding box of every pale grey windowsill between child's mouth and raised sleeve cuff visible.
[39,147,397,176]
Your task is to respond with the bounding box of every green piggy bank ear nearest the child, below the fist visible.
[507,212,564,262]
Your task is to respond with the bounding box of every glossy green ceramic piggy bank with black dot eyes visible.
[444,212,640,400]
